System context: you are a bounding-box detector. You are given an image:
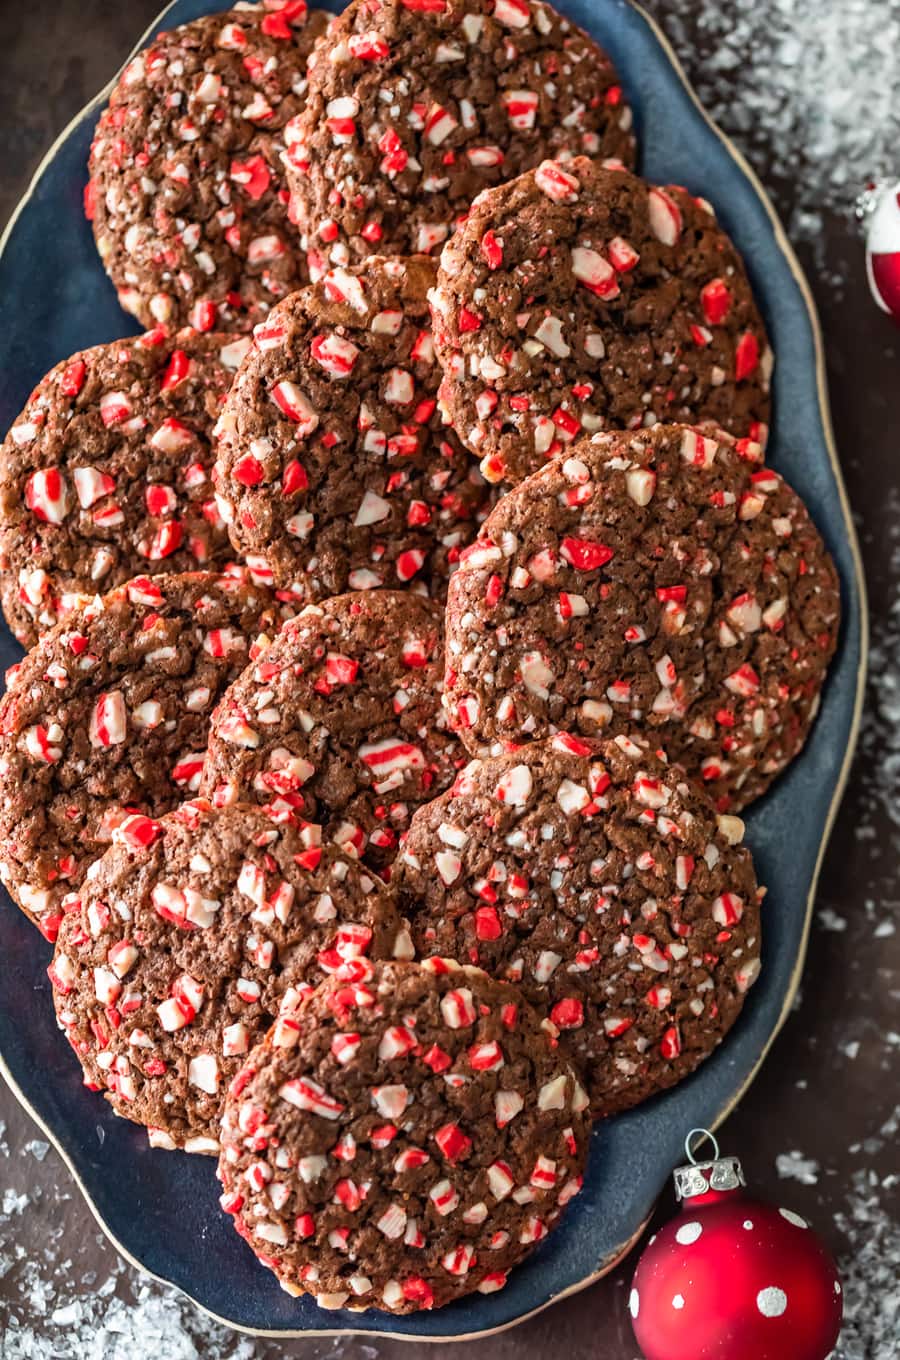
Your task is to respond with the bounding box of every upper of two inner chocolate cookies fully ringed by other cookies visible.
[216,256,489,600]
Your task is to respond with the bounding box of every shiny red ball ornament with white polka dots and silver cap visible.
[628,1129,843,1360]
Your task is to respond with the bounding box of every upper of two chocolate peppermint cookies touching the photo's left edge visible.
[0,328,250,646]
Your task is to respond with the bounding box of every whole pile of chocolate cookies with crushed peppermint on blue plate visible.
[0,0,840,1312]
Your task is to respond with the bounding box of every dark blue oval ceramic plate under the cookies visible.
[0,0,866,1338]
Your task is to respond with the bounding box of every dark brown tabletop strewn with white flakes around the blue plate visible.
[0,0,900,1360]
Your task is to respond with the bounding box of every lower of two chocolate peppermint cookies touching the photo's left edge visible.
[0,568,289,940]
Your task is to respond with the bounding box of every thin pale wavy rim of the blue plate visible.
[0,0,870,1345]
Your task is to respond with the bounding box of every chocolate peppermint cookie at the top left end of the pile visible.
[84,0,329,330]
